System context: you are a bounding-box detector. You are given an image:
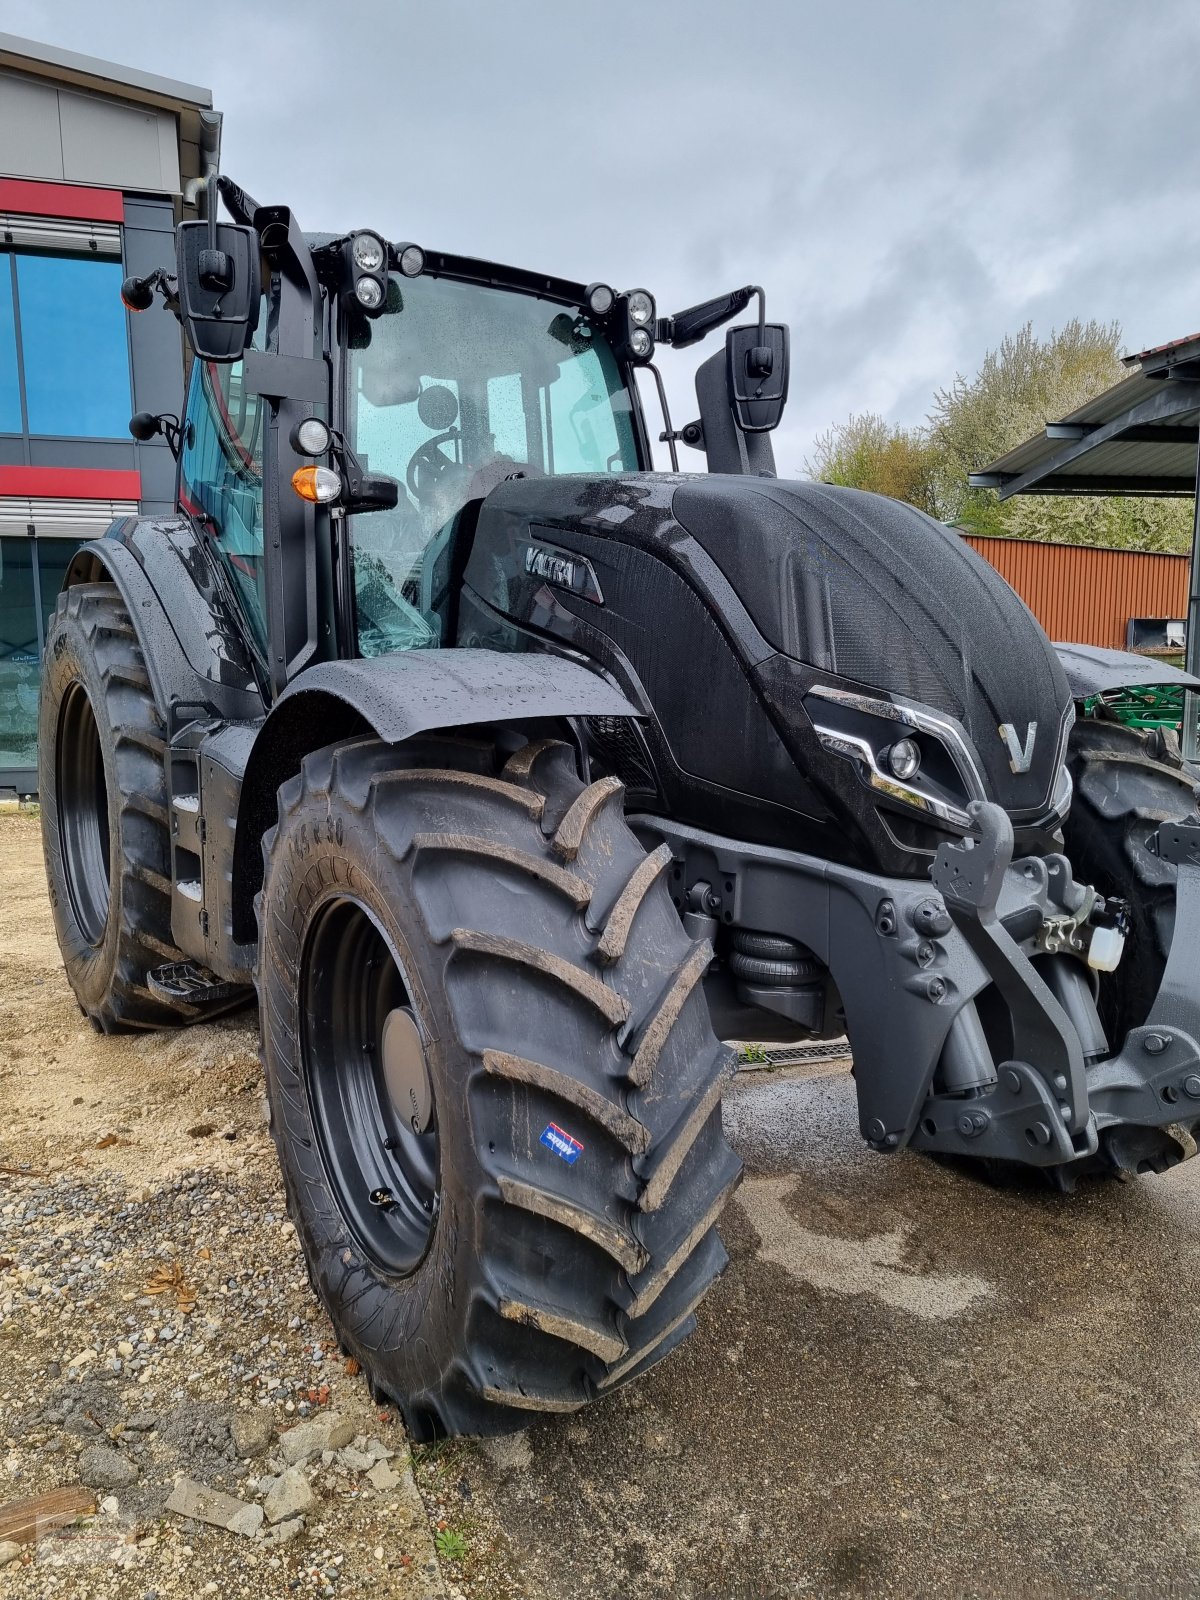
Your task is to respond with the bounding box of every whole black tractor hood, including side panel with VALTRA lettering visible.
[461,474,1072,826]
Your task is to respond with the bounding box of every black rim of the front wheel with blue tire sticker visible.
[301,898,438,1277]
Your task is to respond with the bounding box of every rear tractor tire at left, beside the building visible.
[38,582,197,1034]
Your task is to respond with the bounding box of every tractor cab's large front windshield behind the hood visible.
[347,275,638,656]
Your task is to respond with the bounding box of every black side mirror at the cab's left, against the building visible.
[174,222,262,362]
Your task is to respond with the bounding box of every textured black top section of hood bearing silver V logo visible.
[672,477,1072,816]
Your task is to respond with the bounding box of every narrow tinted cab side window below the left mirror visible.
[179,360,266,650]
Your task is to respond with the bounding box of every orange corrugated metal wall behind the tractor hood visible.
[963,534,1187,650]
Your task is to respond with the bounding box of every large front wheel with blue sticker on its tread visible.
[259,739,741,1440]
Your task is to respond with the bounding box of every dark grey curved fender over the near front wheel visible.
[234,650,642,942]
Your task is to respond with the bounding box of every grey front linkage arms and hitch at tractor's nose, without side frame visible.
[910,805,1200,1181]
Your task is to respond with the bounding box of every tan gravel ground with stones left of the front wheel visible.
[0,816,507,1600]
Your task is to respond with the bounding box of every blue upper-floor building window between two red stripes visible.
[0,251,131,440]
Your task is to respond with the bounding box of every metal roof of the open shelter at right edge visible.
[970,334,1200,499]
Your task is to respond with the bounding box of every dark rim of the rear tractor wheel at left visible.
[54,683,110,947]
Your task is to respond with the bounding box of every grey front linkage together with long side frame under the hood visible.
[649,803,1200,1187]
